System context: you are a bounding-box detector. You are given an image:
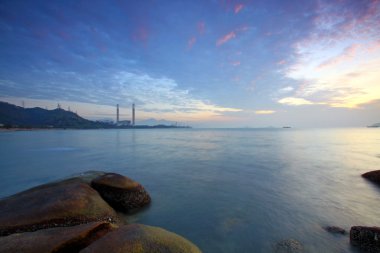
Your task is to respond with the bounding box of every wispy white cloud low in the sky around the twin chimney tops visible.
[0,71,241,120]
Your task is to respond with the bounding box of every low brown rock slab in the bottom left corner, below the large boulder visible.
[0,222,115,253]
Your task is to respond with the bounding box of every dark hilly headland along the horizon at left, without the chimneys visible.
[0,101,190,129]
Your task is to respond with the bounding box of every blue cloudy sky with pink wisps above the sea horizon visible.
[0,0,380,127]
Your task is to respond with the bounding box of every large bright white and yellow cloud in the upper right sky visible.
[279,1,380,108]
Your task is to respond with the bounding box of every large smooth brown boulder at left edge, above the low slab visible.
[0,179,117,236]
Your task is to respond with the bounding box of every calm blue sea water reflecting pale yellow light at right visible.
[0,128,380,253]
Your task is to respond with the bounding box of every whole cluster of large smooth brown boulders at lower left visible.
[0,172,201,253]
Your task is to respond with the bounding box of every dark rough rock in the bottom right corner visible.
[350,226,380,252]
